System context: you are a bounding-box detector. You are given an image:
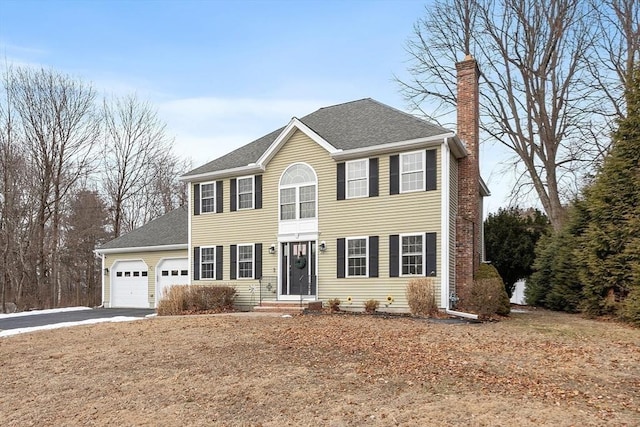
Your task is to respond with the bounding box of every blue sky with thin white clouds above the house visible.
[0,0,506,210]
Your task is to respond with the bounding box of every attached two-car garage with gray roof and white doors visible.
[95,206,190,308]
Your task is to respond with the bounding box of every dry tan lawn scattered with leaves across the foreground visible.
[0,311,640,426]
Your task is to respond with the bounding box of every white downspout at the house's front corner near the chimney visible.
[440,137,478,320]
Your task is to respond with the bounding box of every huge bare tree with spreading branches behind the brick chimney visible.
[399,0,637,228]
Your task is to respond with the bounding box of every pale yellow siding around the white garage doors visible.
[102,249,187,308]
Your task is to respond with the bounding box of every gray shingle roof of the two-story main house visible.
[184,98,451,176]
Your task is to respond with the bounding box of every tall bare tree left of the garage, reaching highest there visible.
[8,68,100,306]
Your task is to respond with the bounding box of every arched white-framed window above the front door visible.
[280,163,317,221]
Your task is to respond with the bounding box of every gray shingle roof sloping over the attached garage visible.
[98,206,189,251]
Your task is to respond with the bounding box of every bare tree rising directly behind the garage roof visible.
[103,95,171,237]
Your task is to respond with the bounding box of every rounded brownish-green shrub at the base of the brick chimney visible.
[467,264,511,319]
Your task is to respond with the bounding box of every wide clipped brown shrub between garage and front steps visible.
[158,285,236,316]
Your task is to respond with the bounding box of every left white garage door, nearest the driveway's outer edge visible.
[111,261,149,308]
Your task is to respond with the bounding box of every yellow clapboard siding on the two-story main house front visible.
[191,131,442,310]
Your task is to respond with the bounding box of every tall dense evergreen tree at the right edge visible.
[577,68,640,318]
